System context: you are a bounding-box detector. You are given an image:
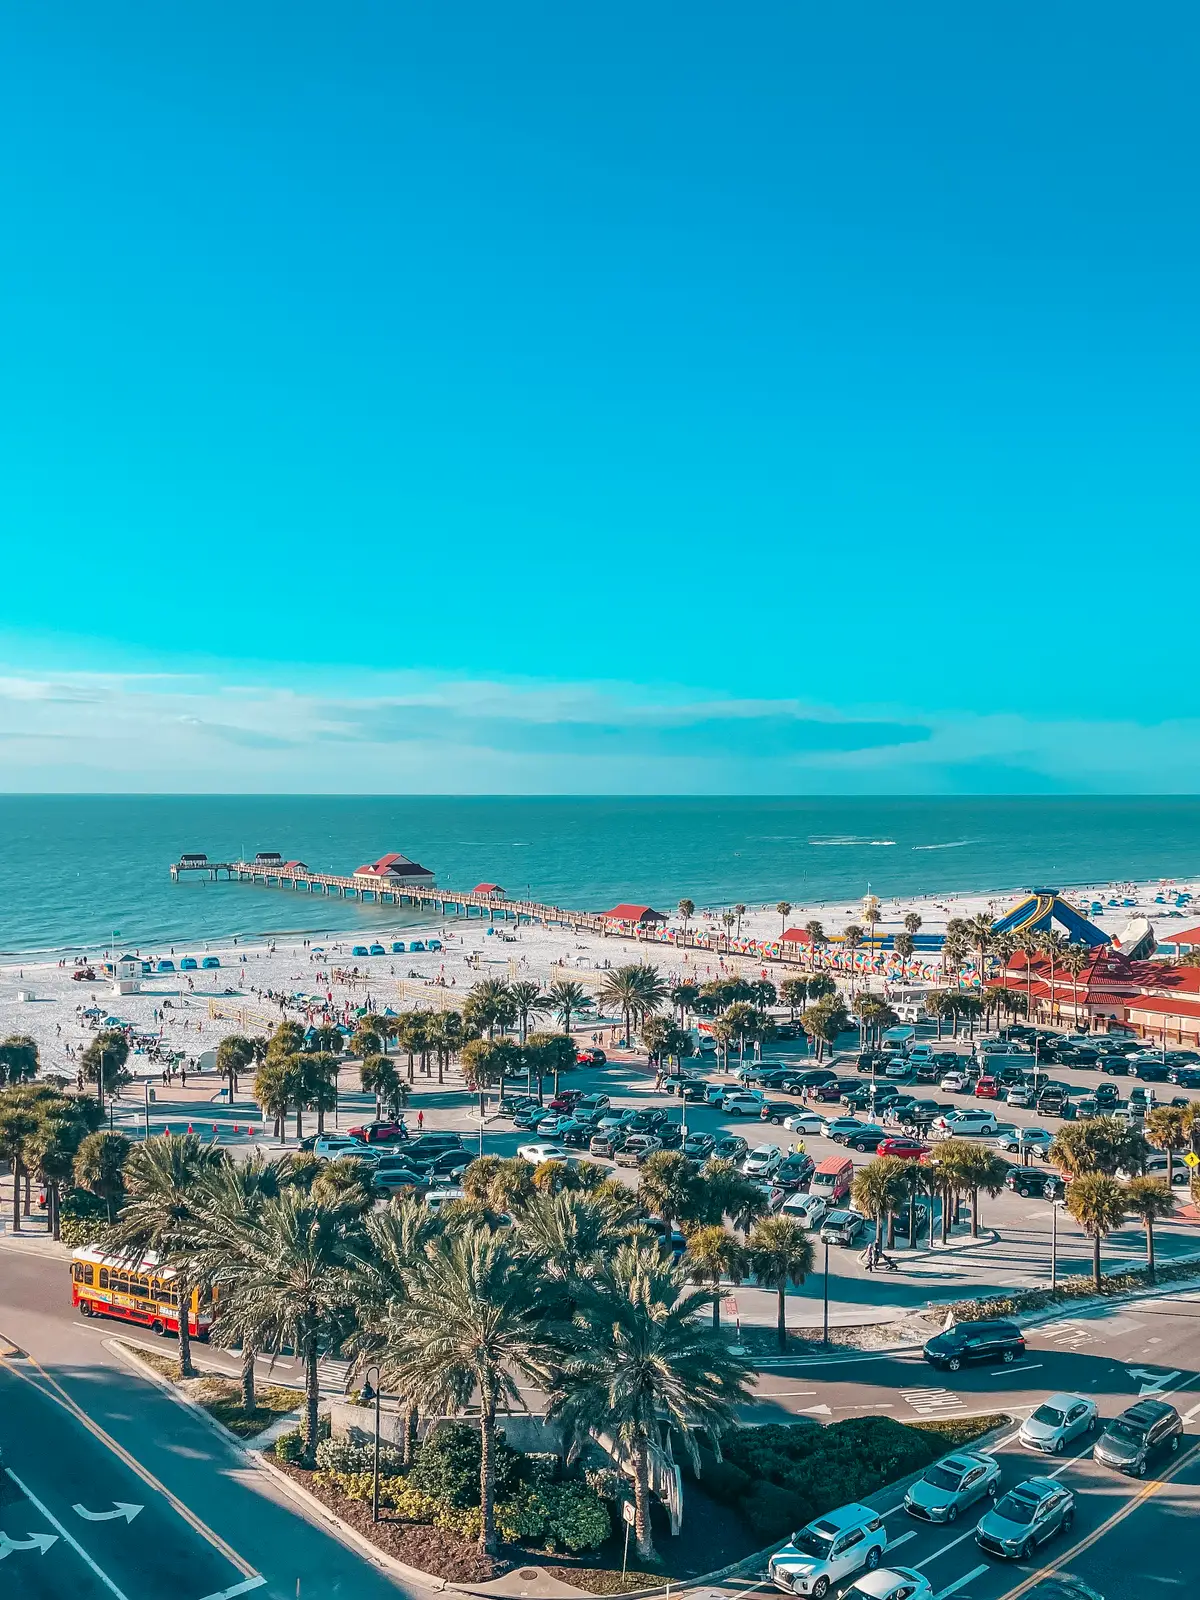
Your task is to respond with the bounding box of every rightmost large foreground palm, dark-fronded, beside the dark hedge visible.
[549,1245,749,1560]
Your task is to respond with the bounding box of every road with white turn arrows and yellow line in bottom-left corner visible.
[0,1251,438,1600]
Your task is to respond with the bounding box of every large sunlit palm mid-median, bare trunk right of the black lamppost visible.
[381,1226,550,1550]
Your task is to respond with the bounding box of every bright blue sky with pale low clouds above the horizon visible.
[0,0,1200,792]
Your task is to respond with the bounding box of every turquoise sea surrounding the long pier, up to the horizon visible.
[0,795,1200,954]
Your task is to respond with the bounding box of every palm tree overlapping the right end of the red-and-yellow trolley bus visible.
[104,1133,227,1378]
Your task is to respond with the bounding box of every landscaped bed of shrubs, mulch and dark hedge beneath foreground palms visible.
[262,1414,1006,1594]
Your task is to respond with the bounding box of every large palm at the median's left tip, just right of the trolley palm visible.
[214,1187,365,1466]
